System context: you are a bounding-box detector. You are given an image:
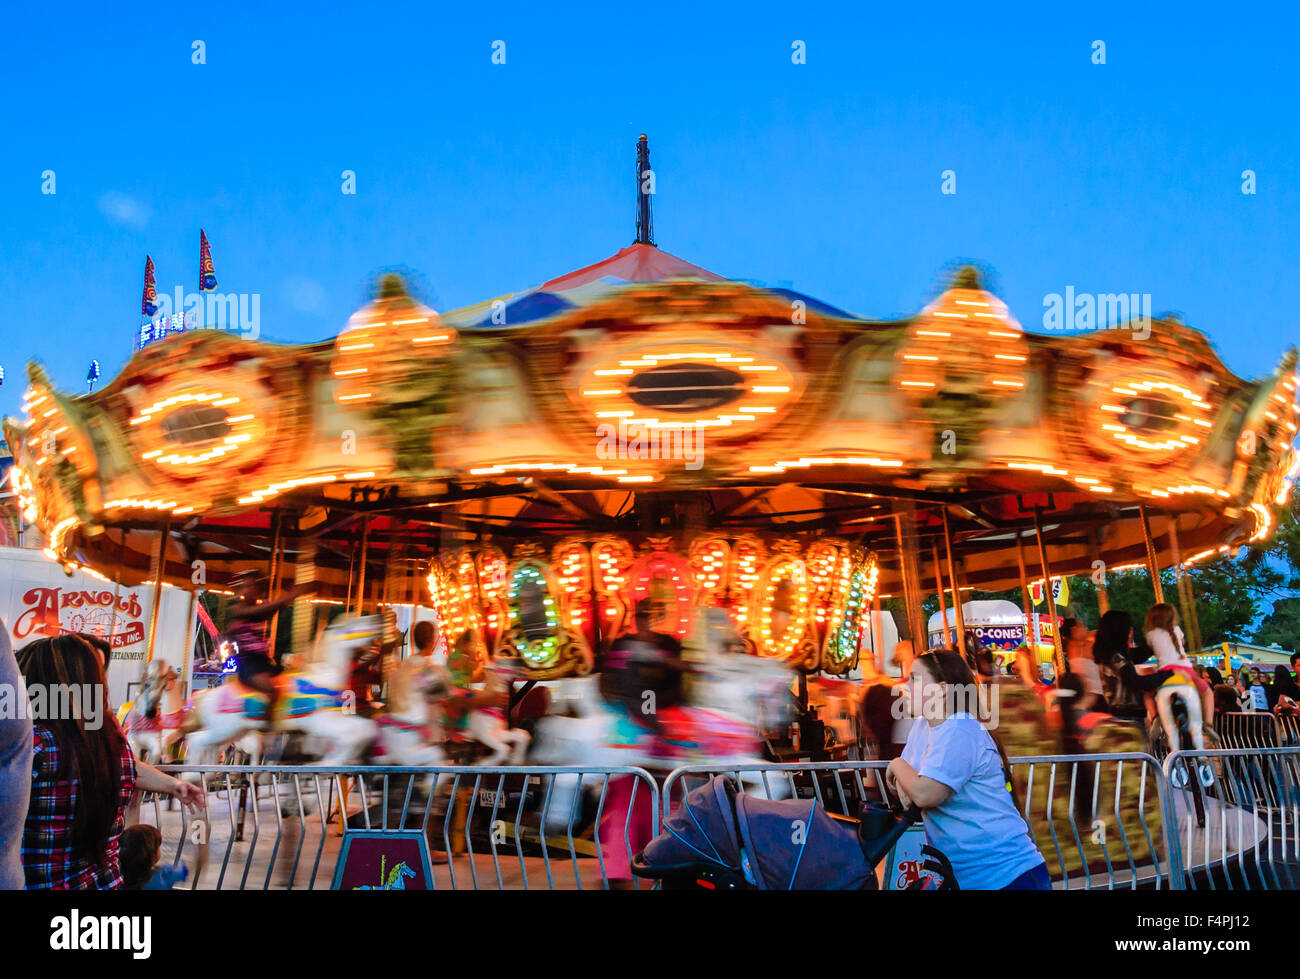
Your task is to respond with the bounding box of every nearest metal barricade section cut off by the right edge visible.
[1165,748,1300,889]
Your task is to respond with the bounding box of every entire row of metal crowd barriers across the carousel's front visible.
[138,748,1300,889]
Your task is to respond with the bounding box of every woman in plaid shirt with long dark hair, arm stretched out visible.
[17,634,204,891]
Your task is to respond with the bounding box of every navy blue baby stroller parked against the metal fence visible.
[632,775,957,891]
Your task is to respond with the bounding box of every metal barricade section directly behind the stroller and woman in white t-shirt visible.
[662,753,1182,889]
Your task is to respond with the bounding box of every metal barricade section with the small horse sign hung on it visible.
[147,764,660,891]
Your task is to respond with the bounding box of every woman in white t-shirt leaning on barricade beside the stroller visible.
[887,650,1052,891]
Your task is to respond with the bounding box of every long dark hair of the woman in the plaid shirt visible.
[17,633,126,865]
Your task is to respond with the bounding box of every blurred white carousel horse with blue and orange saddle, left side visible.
[189,615,384,766]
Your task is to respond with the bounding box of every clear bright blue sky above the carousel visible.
[0,3,1300,413]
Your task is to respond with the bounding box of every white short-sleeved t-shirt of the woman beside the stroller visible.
[902,714,1044,891]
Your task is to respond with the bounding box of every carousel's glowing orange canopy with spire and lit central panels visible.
[4,143,1297,748]
